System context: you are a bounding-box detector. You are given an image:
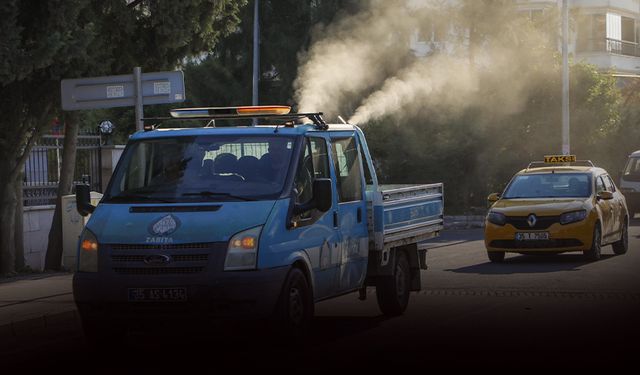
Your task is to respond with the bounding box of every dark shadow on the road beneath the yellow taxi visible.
[445,254,614,275]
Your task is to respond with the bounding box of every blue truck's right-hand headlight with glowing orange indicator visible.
[224,226,262,271]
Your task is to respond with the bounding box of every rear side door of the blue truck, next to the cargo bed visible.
[331,134,369,291]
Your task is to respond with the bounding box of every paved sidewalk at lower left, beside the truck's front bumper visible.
[0,273,78,341]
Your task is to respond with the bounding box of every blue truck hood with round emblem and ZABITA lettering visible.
[87,201,275,244]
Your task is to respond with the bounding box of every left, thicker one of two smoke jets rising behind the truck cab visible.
[295,0,414,115]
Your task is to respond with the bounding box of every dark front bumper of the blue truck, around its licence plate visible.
[73,267,288,319]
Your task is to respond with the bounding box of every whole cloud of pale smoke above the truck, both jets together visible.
[296,0,551,125]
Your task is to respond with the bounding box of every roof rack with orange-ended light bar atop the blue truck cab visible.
[142,106,328,131]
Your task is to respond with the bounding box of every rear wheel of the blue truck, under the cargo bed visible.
[376,251,411,316]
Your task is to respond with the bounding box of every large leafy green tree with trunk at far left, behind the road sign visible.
[0,0,245,274]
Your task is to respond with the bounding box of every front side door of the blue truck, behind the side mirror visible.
[289,137,340,299]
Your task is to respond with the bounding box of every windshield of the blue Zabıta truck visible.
[105,135,294,203]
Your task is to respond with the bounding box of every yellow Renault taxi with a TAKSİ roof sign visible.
[484,155,629,262]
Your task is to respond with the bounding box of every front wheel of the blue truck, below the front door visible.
[277,267,314,335]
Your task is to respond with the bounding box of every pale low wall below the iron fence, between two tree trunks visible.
[23,206,55,271]
